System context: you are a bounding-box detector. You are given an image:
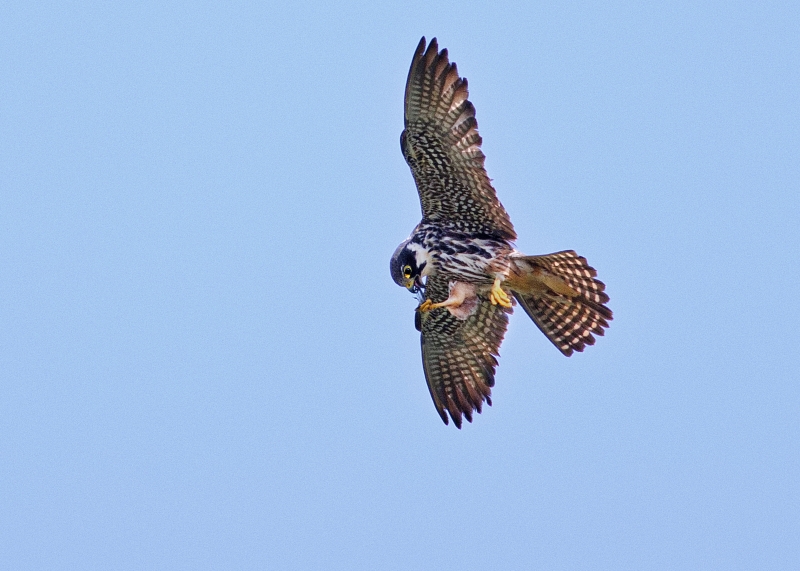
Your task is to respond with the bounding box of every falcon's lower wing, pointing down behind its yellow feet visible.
[417,276,511,428]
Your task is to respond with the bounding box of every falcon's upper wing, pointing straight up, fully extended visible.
[400,37,516,240]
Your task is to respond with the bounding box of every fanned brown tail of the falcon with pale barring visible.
[509,250,613,357]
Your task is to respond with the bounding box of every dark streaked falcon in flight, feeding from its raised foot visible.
[390,37,612,428]
